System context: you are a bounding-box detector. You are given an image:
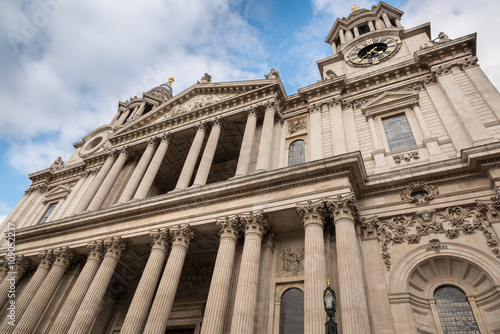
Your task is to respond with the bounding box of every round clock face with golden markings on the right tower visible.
[349,37,399,66]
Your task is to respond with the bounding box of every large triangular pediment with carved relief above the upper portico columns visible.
[113,79,285,137]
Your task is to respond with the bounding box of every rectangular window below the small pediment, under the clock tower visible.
[382,114,416,151]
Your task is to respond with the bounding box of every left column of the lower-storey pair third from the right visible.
[120,229,169,334]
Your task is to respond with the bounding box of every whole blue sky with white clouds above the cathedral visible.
[0,0,500,221]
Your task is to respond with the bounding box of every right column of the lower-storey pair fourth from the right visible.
[68,237,125,334]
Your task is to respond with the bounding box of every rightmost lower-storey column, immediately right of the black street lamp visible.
[326,196,371,334]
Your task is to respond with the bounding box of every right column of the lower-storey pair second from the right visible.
[231,212,269,334]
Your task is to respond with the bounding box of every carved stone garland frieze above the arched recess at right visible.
[361,205,500,271]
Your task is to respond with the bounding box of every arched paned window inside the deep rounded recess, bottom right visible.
[434,286,480,334]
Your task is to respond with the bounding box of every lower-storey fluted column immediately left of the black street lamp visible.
[297,201,326,334]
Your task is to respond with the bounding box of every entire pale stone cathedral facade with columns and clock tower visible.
[0,2,500,334]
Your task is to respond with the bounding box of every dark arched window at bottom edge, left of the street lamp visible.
[280,288,304,334]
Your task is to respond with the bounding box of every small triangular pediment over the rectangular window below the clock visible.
[361,91,418,116]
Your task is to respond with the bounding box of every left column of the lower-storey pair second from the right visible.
[201,217,238,334]
